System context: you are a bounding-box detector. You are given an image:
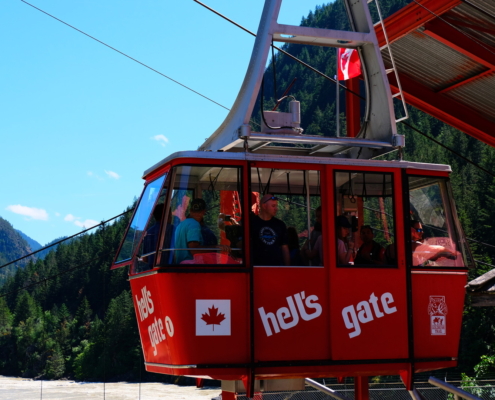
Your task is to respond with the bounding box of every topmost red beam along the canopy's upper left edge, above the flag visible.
[375,0,461,47]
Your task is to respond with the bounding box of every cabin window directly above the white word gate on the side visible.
[335,171,397,267]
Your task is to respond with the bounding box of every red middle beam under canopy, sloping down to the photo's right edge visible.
[423,19,495,69]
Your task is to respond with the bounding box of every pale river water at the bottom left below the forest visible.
[0,376,221,400]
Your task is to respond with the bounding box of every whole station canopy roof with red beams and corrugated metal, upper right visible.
[376,0,495,147]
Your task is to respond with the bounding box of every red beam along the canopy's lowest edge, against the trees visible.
[390,75,495,147]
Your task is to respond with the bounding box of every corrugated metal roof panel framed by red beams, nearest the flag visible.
[382,31,486,92]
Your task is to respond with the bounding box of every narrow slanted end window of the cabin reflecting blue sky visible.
[115,175,166,263]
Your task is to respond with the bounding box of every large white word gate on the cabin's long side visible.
[342,292,397,338]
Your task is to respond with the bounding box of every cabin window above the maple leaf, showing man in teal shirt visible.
[159,165,243,266]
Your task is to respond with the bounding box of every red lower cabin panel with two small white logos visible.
[412,271,467,359]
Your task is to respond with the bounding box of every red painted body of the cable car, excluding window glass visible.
[121,159,466,384]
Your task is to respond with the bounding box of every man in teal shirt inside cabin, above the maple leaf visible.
[174,199,230,264]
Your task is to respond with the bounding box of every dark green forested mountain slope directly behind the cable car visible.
[0,0,495,380]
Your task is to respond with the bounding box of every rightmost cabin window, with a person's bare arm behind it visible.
[409,176,467,267]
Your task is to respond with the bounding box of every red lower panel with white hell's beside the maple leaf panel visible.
[254,267,331,361]
